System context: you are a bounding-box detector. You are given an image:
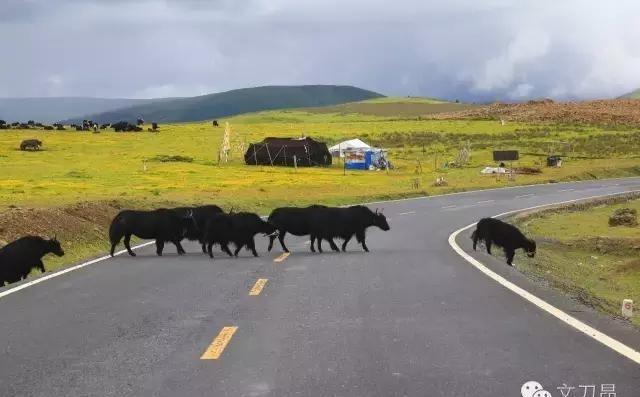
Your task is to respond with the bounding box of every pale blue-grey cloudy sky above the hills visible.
[0,0,640,100]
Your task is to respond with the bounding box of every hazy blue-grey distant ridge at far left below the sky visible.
[0,97,157,123]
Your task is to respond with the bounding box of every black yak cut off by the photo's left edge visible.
[0,236,64,287]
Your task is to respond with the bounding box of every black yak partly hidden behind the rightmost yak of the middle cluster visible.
[267,205,327,252]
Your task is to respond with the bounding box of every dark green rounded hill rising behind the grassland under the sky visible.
[67,85,383,123]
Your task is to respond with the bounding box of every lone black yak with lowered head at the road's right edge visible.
[471,218,536,266]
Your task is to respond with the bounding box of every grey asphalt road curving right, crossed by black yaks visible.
[0,178,640,397]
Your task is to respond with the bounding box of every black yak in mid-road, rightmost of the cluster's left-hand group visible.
[204,212,276,258]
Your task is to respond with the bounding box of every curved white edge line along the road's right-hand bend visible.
[449,190,640,364]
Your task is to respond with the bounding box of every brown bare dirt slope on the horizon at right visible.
[430,99,640,126]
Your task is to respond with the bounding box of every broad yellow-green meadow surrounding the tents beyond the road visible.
[0,98,640,276]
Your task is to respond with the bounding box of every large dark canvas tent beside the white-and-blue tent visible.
[244,138,331,167]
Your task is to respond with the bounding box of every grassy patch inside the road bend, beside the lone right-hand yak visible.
[517,198,640,326]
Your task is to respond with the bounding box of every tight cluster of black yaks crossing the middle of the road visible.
[109,205,390,258]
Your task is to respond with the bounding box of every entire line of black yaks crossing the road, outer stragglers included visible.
[0,201,536,287]
